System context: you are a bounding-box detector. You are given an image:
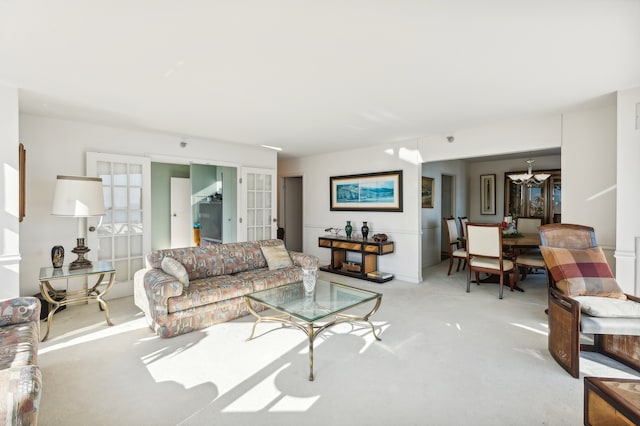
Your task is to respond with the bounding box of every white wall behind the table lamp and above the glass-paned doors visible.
[16,114,277,295]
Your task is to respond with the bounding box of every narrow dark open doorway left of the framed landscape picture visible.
[280,176,302,252]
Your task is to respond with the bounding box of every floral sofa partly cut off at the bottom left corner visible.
[0,297,42,425]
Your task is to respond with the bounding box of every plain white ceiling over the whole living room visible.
[0,0,640,156]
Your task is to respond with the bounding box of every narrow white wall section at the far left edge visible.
[0,85,19,299]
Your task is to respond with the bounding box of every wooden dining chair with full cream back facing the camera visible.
[466,223,516,299]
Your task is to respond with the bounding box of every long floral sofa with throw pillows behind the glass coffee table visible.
[134,239,318,337]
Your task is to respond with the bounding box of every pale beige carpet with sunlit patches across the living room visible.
[39,263,638,426]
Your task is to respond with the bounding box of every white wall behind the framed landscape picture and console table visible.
[278,140,421,283]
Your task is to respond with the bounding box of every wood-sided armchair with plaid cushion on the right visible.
[540,224,640,378]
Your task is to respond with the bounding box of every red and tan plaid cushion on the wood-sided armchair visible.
[540,246,627,299]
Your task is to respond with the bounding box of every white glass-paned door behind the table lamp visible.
[87,152,151,298]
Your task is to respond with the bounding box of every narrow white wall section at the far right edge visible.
[610,87,640,295]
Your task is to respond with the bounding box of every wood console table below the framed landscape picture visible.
[318,236,395,283]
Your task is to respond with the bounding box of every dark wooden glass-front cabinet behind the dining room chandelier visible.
[504,170,562,224]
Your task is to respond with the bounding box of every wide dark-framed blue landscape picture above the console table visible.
[329,170,402,212]
